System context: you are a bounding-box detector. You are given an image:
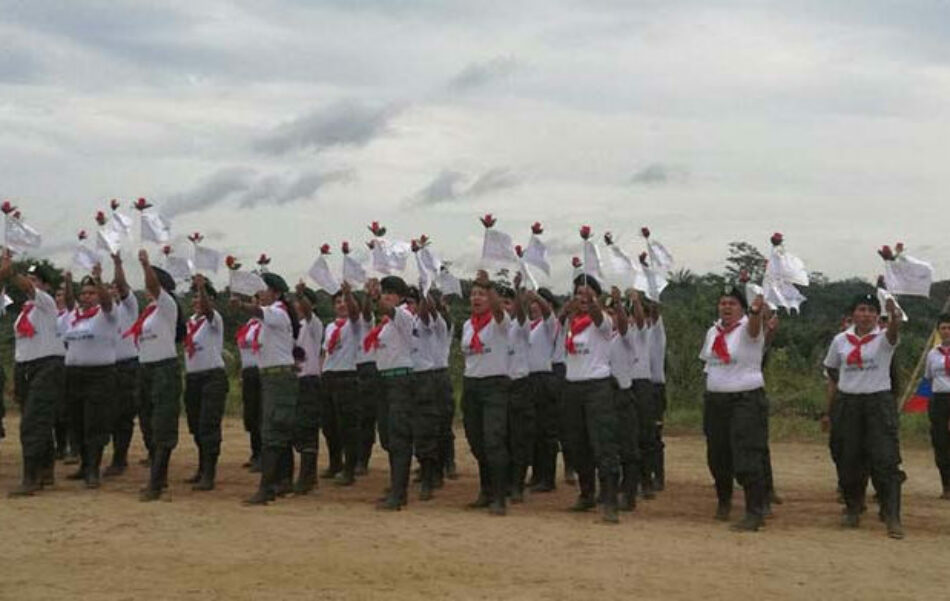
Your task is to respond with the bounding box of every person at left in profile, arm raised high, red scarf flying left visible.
[134,250,185,502]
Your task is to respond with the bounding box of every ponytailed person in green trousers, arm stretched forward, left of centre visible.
[231,272,300,505]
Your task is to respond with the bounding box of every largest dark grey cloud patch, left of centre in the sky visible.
[254,100,400,155]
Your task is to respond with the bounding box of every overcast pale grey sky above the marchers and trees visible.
[0,0,950,288]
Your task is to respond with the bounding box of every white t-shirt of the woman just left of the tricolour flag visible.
[825,326,897,394]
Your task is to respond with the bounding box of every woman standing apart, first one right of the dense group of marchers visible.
[699,287,768,532]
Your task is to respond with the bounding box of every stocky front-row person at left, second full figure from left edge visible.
[63,264,118,488]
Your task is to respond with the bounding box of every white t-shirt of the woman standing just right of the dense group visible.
[699,316,765,392]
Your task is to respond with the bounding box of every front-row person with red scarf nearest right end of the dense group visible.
[561,274,620,524]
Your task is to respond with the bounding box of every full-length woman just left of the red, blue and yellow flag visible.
[824,294,904,538]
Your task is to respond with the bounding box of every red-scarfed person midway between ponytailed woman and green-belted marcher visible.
[321,282,363,486]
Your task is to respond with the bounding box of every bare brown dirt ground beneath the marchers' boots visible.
[0,420,950,601]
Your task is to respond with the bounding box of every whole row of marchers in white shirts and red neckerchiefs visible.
[0,244,950,538]
